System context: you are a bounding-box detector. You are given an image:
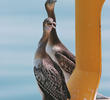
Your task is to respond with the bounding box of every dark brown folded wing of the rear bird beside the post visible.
[55,52,75,74]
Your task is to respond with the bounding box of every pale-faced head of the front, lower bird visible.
[43,18,56,33]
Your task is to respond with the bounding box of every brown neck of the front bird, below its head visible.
[35,33,48,58]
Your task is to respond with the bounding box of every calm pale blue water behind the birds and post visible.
[0,0,110,100]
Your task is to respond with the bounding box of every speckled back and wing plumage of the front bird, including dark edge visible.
[34,56,70,100]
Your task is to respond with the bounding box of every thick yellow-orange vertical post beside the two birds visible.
[68,0,104,100]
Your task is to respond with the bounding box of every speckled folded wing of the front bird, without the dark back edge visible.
[34,59,69,100]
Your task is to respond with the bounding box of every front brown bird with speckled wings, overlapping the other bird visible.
[34,18,70,100]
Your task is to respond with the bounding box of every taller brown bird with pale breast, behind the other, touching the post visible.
[45,0,76,82]
